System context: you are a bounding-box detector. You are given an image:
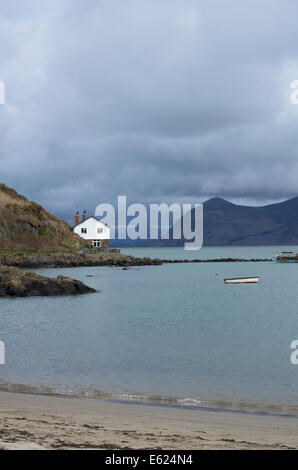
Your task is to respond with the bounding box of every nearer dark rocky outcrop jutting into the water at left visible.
[0,266,96,297]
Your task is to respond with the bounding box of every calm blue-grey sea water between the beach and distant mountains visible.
[0,247,298,413]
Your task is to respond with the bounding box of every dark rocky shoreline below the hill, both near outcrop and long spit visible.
[0,253,272,297]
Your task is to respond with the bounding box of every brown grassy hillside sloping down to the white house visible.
[0,184,84,250]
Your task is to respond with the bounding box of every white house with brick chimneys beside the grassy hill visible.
[73,211,110,248]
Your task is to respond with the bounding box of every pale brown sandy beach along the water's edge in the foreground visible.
[0,392,298,450]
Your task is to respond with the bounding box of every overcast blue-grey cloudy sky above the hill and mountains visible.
[0,0,298,220]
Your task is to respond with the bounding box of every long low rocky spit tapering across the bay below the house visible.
[0,253,273,269]
